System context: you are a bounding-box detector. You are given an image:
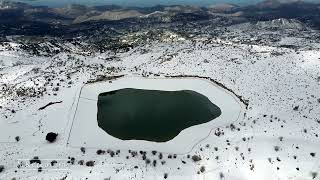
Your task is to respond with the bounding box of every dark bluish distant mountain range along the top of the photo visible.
[0,0,320,36]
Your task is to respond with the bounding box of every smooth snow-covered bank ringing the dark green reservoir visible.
[68,77,245,154]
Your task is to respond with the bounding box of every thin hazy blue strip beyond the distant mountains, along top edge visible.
[16,0,320,6]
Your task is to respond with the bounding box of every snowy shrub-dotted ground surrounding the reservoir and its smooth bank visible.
[0,40,320,180]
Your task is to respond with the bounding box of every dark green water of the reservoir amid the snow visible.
[97,88,221,142]
